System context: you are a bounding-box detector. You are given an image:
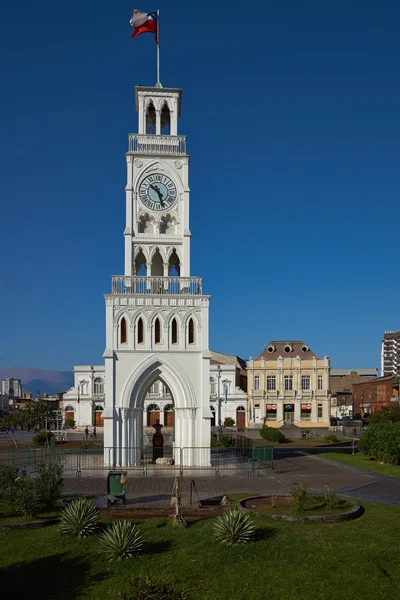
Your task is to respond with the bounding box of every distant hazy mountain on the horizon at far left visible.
[0,367,74,396]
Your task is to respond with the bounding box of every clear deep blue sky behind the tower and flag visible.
[0,0,400,369]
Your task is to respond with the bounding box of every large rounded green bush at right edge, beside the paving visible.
[358,422,400,465]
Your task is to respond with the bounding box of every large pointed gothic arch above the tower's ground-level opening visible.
[120,354,196,409]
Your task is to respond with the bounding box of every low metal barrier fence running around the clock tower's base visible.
[0,435,274,475]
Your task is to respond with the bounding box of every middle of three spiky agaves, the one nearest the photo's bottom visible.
[100,521,143,560]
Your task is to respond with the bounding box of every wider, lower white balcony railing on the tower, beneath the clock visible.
[112,275,203,296]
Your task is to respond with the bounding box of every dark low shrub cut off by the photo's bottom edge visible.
[118,576,190,600]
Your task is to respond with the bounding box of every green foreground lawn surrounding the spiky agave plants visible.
[0,501,400,600]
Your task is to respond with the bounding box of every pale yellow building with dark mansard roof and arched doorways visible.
[247,341,330,429]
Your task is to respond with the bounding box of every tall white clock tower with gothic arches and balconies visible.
[103,86,211,466]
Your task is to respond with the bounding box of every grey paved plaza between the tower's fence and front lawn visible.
[64,450,400,508]
